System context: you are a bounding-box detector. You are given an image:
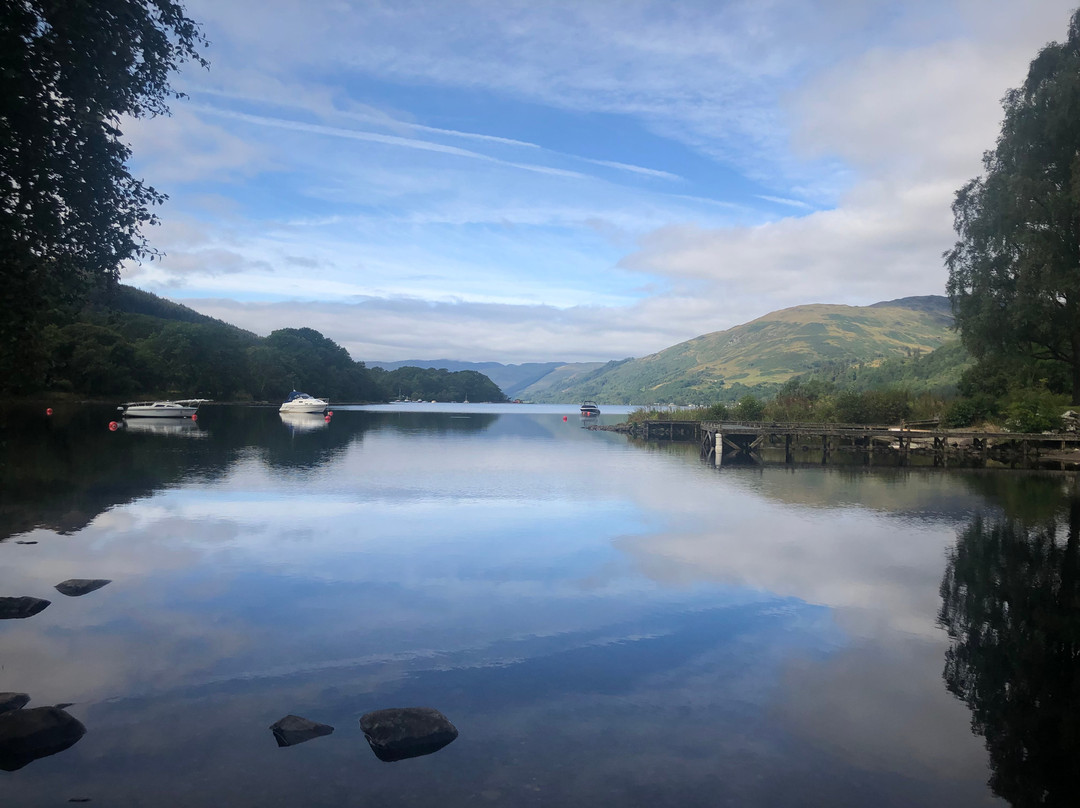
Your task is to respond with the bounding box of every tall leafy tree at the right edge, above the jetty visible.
[945,10,1080,402]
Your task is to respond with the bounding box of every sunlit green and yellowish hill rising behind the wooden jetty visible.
[525,296,954,404]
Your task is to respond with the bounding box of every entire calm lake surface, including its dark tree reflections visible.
[0,404,1080,808]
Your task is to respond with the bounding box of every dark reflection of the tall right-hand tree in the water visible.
[939,495,1080,806]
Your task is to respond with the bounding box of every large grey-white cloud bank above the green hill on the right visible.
[621,3,1066,313]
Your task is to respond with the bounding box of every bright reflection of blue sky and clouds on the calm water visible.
[0,406,1036,805]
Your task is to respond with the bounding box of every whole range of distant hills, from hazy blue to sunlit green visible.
[367,295,970,405]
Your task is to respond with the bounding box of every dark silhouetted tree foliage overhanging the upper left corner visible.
[0,0,207,390]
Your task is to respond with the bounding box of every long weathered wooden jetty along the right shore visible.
[631,420,1080,469]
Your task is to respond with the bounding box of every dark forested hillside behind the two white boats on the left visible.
[28,285,504,402]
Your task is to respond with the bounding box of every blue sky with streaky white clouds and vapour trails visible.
[122,0,1077,363]
